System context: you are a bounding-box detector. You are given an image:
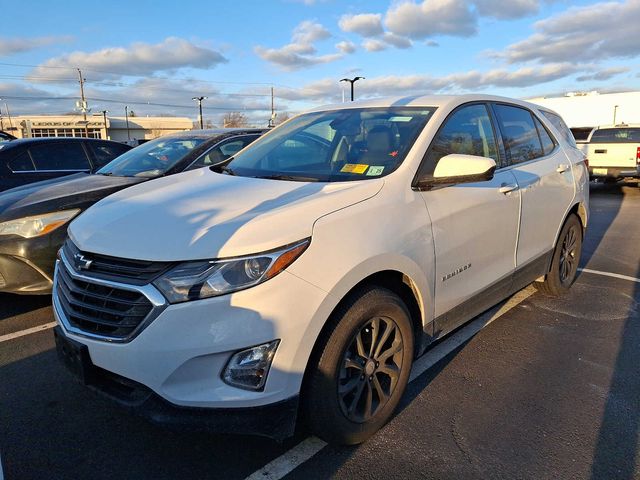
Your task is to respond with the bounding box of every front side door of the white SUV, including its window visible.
[421,103,520,337]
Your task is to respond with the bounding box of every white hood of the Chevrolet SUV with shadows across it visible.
[69,168,384,261]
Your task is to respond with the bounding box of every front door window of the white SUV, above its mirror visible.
[420,104,499,177]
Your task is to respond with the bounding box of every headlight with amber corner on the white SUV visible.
[153,239,311,303]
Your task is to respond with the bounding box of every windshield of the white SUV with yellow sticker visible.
[223,107,435,182]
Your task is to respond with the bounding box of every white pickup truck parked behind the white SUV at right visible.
[578,125,640,186]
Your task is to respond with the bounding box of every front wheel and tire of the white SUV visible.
[303,287,414,445]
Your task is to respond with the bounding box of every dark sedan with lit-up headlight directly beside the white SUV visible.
[0,129,262,294]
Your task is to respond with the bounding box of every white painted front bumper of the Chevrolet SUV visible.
[53,256,327,436]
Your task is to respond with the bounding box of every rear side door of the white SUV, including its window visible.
[493,103,575,278]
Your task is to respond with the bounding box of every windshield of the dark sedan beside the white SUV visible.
[96,137,206,177]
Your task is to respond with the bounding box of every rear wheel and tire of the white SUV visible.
[536,214,583,297]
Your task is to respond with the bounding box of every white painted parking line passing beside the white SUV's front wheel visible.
[245,285,536,480]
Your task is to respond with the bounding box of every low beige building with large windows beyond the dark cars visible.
[0,115,193,142]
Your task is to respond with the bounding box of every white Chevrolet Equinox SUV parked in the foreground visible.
[53,95,588,444]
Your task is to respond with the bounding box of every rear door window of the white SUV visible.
[495,105,544,163]
